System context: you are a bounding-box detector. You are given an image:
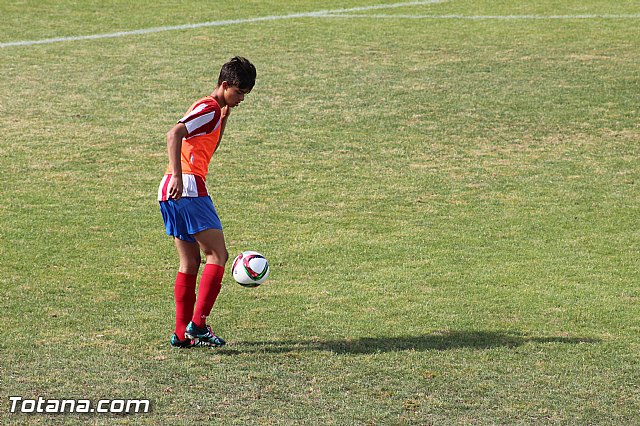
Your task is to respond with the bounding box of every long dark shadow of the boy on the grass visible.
[218,331,599,355]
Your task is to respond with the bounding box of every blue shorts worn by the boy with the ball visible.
[160,196,222,243]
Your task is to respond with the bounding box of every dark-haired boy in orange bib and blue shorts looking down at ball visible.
[158,56,256,348]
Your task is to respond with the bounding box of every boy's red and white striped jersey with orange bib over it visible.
[158,96,222,201]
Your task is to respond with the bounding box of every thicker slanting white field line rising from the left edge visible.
[0,0,449,48]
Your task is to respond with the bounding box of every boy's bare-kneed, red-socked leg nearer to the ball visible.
[192,229,229,328]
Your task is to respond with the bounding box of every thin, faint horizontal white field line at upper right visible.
[319,14,640,20]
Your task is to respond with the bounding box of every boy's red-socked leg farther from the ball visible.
[173,238,201,339]
